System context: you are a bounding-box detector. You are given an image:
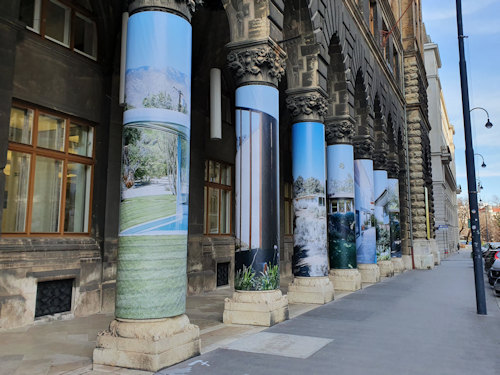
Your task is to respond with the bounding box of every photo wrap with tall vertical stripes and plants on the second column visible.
[235,85,280,290]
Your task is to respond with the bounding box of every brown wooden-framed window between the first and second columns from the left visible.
[203,160,233,236]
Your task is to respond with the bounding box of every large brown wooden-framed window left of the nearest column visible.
[2,103,95,236]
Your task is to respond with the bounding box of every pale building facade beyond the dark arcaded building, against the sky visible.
[424,36,459,262]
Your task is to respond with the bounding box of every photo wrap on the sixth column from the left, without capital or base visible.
[373,170,391,260]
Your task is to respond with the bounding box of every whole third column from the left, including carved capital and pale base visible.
[286,90,334,304]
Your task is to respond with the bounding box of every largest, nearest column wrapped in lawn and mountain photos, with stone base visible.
[94,0,200,371]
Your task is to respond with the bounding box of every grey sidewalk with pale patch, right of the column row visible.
[158,252,500,375]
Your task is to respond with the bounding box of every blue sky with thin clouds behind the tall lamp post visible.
[422,0,500,206]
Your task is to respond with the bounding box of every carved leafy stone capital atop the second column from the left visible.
[227,40,286,87]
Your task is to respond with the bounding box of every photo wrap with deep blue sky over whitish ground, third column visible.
[292,122,330,277]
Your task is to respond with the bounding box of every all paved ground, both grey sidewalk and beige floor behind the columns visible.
[0,252,500,375]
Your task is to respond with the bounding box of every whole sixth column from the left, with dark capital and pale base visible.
[373,151,394,277]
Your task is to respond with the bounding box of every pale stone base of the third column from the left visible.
[287,276,335,305]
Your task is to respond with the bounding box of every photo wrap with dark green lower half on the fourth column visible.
[326,144,357,269]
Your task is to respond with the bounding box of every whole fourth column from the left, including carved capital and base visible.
[326,119,361,291]
